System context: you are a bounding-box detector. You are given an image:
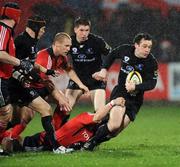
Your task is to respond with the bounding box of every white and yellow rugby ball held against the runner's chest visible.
[126,71,142,85]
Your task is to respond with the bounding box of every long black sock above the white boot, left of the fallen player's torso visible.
[41,115,59,149]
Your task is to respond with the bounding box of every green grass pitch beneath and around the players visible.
[0,105,180,167]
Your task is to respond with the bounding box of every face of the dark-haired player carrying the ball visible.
[135,39,152,58]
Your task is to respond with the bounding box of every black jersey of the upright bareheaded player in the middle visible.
[70,34,111,78]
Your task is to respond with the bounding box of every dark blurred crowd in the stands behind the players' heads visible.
[0,0,180,62]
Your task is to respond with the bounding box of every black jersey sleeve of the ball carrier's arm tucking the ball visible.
[136,56,158,91]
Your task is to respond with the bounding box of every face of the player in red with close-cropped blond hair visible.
[53,38,72,56]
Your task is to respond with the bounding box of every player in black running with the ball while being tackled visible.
[84,33,158,150]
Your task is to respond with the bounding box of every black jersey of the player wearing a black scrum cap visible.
[14,31,38,63]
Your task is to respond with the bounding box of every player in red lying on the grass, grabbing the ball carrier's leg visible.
[1,97,125,152]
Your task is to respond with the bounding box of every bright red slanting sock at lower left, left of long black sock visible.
[11,123,26,139]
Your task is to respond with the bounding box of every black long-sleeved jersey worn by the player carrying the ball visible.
[102,44,158,99]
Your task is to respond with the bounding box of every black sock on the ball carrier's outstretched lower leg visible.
[92,124,110,143]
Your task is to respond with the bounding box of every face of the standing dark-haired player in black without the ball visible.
[74,25,90,43]
